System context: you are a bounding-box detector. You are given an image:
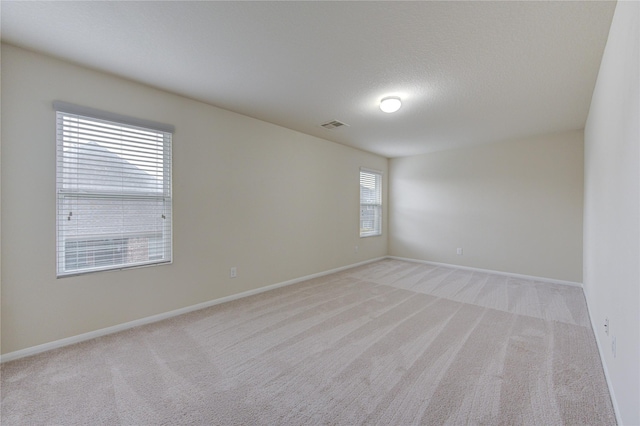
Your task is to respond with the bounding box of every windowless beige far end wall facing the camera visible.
[389,131,583,282]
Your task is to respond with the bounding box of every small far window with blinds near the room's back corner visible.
[360,169,382,237]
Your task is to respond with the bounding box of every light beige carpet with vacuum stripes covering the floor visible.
[1,260,615,425]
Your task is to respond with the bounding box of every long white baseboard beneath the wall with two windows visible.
[0,257,384,363]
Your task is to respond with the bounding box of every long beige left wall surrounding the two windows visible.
[1,45,387,353]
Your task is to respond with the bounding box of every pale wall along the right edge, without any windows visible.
[584,1,640,425]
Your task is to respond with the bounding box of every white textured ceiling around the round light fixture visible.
[1,0,615,157]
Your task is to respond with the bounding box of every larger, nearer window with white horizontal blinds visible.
[54,102,173,276]
